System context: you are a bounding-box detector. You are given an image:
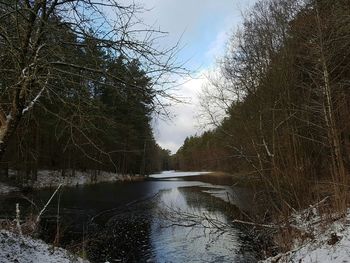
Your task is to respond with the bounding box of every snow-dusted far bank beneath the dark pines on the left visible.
[0,170,146,195]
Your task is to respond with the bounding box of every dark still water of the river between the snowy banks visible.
[0,174,257,262]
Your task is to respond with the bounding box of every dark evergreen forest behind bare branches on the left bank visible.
[0,0,173,184]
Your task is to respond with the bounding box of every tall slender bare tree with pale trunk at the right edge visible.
[301,0,350,211]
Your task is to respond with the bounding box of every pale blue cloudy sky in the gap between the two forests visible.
[136,0,255,153]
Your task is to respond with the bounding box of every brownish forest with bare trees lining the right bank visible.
[173,0,350,210]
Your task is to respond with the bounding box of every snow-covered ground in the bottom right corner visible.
[261,210,350,263]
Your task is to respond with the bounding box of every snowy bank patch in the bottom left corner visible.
[0,230,89,263]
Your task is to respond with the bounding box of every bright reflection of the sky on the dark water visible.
[151,188,240,262]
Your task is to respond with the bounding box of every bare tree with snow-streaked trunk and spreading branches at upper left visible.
[0,0,184,161]
